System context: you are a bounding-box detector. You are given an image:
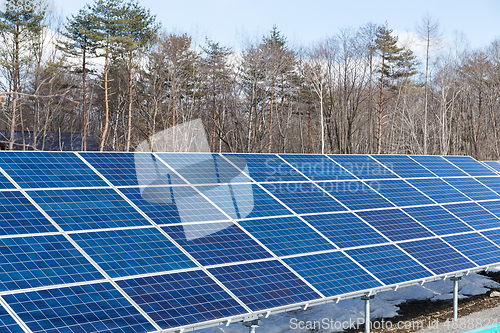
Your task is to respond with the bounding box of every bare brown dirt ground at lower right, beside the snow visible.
[346,272,500,333]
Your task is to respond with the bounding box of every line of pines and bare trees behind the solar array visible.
[0,0,500,160]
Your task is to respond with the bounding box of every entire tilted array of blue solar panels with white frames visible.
[0,152,500,333]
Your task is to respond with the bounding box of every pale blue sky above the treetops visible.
[55,0,500,49]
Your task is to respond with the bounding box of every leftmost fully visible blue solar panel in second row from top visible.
[29,188,151,231]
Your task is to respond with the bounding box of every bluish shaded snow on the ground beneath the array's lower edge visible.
[197,267,500,333]
